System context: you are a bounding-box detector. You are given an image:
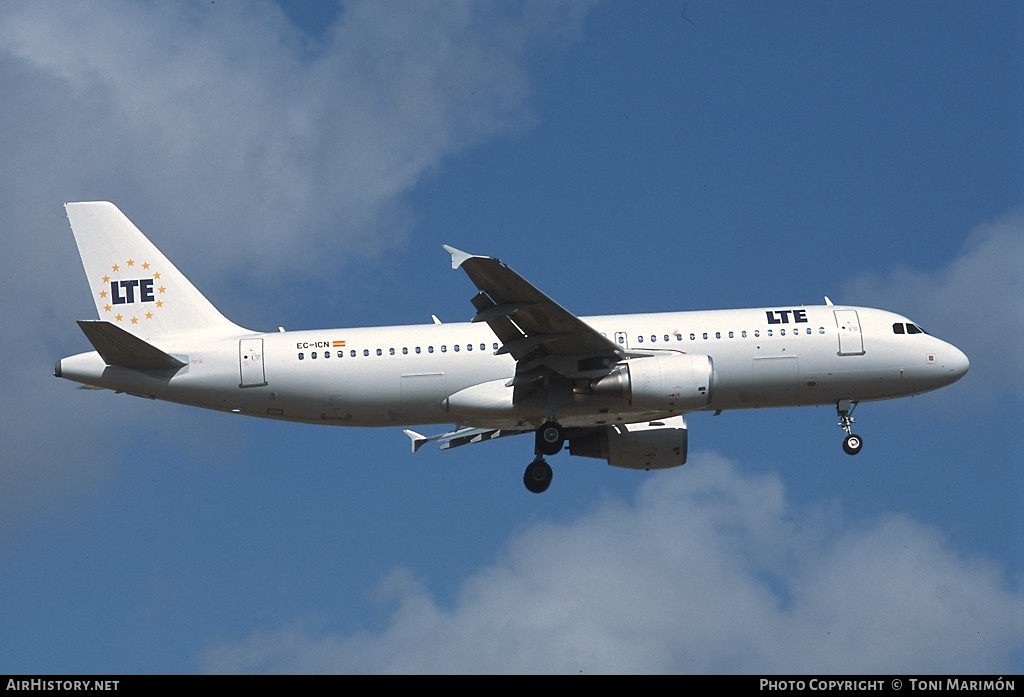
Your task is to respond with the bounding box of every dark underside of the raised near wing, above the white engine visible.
[444,246,628,401]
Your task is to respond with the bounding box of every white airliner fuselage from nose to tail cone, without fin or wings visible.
[56,305,968,428]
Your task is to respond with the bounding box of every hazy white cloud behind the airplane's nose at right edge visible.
[845,210,1024,403]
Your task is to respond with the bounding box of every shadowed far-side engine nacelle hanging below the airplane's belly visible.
[569,417,687,470]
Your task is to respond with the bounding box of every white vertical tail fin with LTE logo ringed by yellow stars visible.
[65,201,249,338]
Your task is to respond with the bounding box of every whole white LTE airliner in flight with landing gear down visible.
[53,202,970,493]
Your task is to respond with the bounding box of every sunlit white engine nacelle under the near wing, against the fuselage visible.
[591,353,715,411]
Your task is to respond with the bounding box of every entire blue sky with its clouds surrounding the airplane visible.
[0,0,1024,674]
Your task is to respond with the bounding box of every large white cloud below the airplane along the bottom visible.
[202,454,1024,673]
